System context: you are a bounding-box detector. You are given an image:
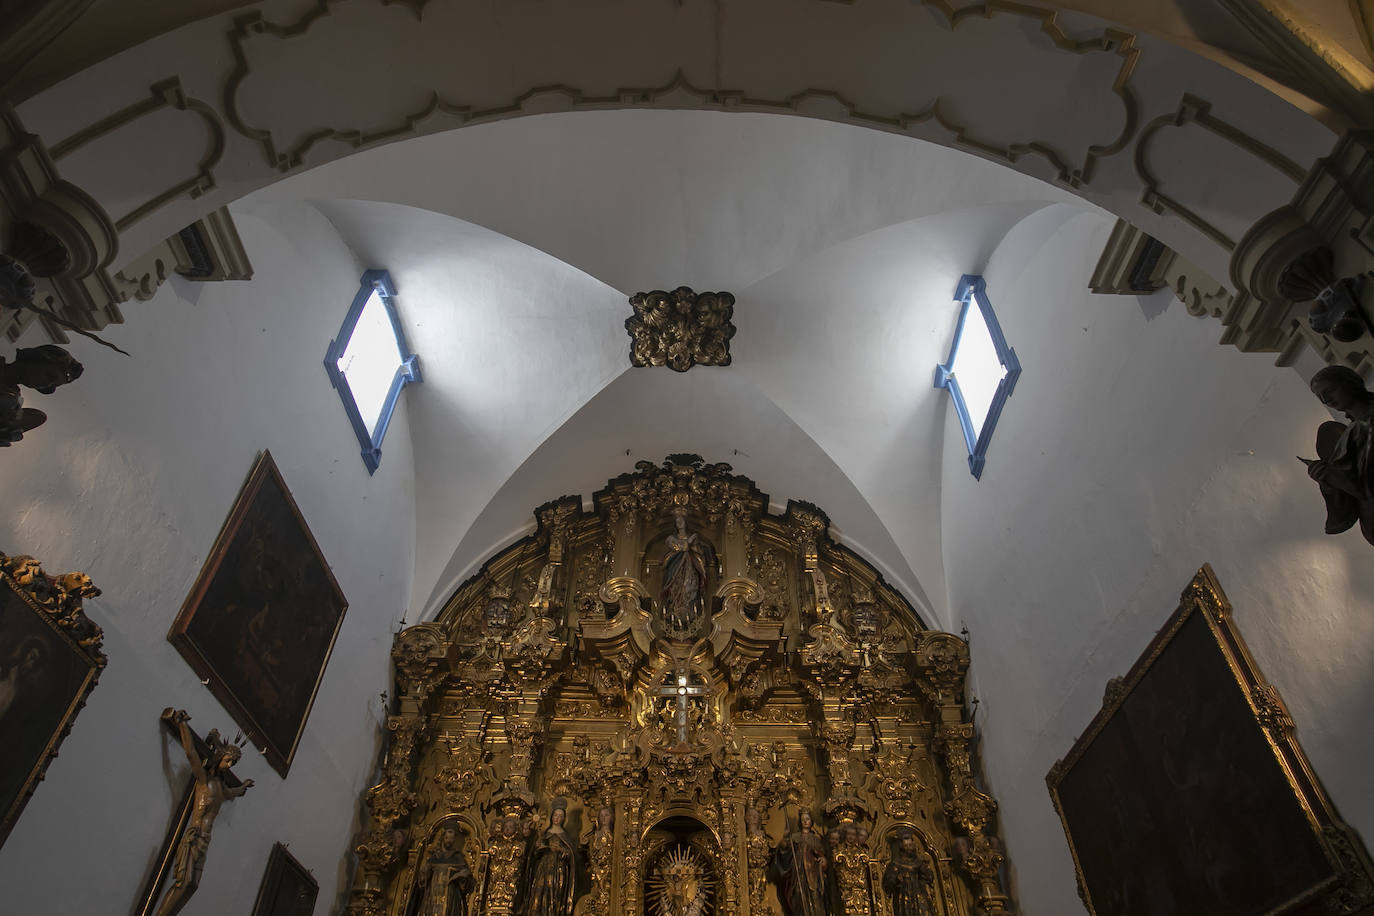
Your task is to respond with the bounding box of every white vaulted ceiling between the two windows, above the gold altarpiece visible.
[238,111,1088,622]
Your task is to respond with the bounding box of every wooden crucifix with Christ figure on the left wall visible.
[133,706,253,916]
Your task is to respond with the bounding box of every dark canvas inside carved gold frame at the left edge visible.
[0,568,100,842]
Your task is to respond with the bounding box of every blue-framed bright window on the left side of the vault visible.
[324,271,420,474]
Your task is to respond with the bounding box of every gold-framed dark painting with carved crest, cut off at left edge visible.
[0,553,106,845]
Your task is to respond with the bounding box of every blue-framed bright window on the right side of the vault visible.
[936,273,1021,478]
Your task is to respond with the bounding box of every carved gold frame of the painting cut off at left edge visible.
[0,553,106,846]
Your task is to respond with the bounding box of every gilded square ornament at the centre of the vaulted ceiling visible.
[625,286,735,372]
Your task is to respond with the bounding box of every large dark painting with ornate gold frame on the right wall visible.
[1046,566,1374,916]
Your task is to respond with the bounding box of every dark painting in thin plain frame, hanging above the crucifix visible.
[168,452,348,779]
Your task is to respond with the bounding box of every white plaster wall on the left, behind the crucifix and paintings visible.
[0,205,415,916]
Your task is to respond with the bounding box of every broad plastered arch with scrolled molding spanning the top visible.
[2,0,1329,282]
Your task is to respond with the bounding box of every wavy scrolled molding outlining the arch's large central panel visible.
[224,0,1140,188]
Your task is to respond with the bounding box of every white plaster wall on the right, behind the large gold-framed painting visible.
[943,213,1374,916]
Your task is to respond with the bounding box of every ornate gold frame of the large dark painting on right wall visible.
[1046,564,1374,916]
